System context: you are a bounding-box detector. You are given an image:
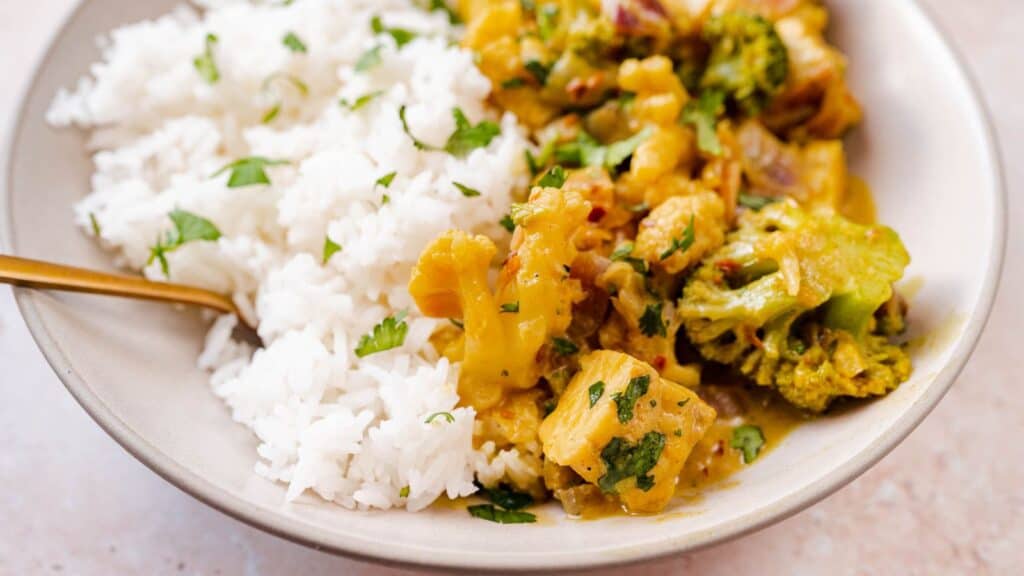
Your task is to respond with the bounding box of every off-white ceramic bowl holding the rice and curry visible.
[0,0,1005,570]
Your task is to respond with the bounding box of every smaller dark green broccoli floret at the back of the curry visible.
[700,12,790,116]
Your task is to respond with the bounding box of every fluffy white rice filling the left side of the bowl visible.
[49,0,527,510]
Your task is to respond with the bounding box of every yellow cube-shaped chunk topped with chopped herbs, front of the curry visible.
[540,351,715,512]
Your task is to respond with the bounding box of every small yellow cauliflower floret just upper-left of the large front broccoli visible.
[634,192,725,274]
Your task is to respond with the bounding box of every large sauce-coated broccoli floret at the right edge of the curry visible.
[678,201,910,412]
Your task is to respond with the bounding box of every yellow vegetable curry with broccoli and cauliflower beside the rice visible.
[410,0,910,522]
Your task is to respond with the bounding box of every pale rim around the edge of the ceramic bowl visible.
[0,0,1009,572]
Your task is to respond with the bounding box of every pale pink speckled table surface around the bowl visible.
[0,0,1024,576]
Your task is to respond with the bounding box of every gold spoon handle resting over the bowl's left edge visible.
[0,254,261,345]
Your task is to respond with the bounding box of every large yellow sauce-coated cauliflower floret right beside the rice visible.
[409,188,590,410]
